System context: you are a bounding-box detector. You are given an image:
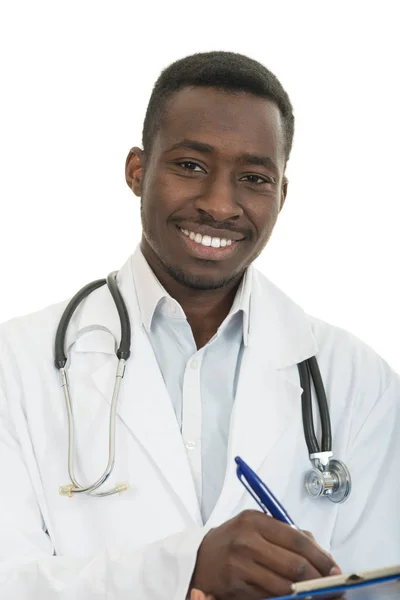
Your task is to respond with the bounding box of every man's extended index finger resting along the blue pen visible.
[253,511,338,577]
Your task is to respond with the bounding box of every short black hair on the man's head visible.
[142,51,294,161]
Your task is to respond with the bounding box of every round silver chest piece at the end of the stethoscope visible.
[304,458,351,504]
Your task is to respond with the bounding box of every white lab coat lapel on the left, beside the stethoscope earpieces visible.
[71,260,201,524]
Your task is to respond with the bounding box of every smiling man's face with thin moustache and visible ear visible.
[126,87,287,290]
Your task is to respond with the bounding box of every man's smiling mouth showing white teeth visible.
[177,227,245,260]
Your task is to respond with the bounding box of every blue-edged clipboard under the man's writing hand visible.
[279,565,400,600]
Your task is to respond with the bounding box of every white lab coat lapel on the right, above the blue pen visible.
[209,271,317,525]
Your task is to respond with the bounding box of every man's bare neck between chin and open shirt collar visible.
[142,247,243,348]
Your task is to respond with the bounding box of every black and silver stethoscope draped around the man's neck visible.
[54,271,351,503]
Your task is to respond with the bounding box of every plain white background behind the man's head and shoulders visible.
[0,0,400,371]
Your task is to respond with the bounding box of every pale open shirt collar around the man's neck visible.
[132,246,253,346]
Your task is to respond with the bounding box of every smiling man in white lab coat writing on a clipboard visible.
[0,52,400,600]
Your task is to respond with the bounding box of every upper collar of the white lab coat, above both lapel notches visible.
[72,251,317,369]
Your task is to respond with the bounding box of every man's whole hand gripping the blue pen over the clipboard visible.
[191,510,340,600]
